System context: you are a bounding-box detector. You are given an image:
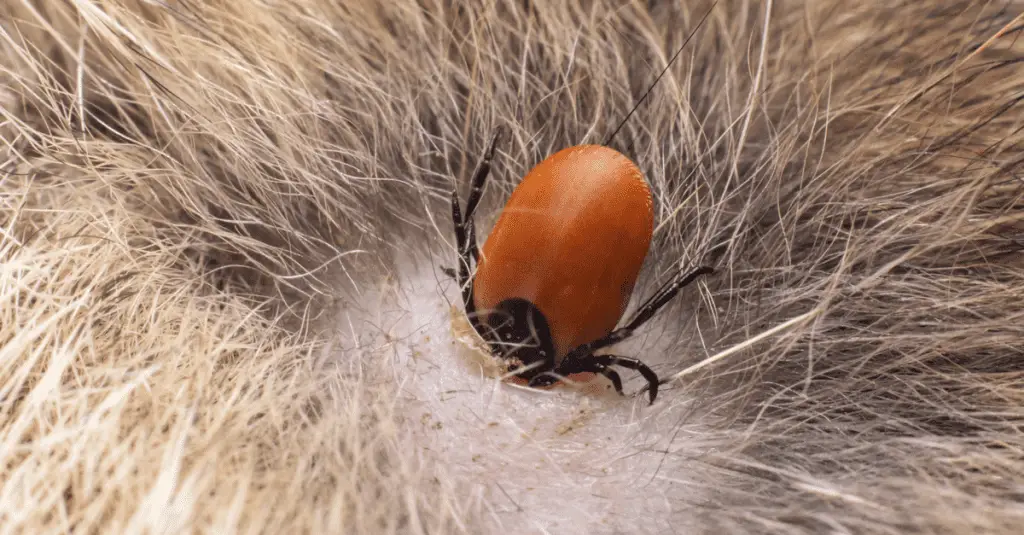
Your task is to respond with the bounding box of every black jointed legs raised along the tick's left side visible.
[441,130,501,319]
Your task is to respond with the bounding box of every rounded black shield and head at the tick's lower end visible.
[483,297,555,380]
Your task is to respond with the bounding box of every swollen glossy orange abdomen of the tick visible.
[474,146,653,363]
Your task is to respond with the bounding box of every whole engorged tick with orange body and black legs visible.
[450,131,714,403]
